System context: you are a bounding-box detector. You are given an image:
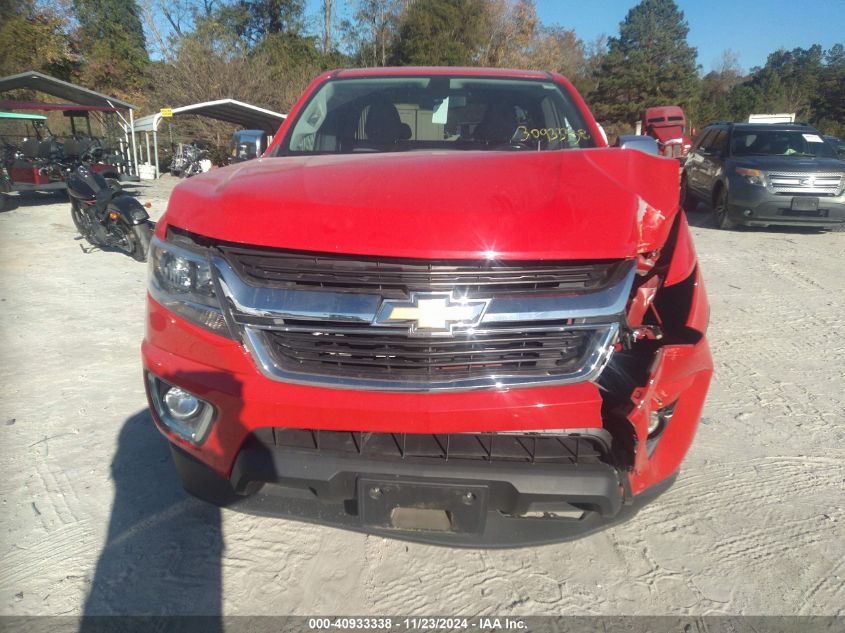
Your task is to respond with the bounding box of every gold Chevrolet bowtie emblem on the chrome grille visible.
[375,293,490,335]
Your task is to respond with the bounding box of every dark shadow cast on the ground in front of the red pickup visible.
[80,410,223,633]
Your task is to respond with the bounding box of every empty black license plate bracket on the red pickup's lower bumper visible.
[358,477,489,534]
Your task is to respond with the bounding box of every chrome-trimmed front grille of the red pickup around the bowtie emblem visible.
[213,247,635,391]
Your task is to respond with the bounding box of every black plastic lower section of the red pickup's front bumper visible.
[173,438,675,548]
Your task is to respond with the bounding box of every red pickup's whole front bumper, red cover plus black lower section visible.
[142,288,712,546]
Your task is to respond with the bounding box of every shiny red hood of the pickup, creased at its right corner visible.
[159,148,678,260]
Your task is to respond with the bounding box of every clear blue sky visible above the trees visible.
[307,0,845,72]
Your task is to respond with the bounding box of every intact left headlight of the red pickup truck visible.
[149,238,231,337]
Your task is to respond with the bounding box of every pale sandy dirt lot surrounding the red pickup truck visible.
[0,178,845,615]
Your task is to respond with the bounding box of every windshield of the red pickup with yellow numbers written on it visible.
[279,76,595,154]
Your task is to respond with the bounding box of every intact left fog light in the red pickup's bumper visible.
[147,374,215,445]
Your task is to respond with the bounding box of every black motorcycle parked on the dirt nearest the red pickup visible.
[67,165,153,262]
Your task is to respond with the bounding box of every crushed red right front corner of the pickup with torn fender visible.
[600,205,713,495]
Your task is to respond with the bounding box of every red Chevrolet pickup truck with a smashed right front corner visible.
[143,68,712,546]
